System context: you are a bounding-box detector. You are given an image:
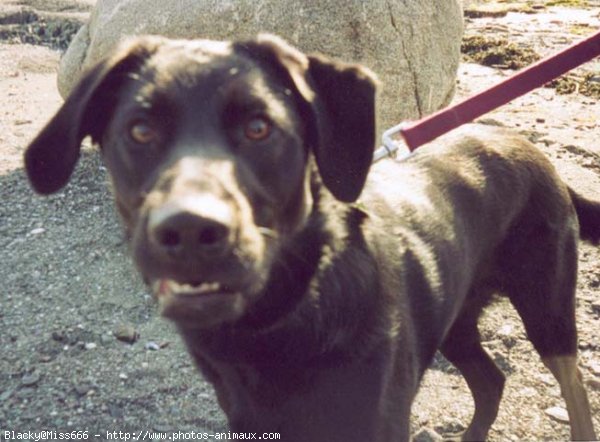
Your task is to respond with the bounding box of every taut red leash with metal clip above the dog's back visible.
[374,28,600,161]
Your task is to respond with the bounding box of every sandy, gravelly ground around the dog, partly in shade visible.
[0,0,600,441]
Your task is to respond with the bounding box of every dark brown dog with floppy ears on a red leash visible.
[25,35,600,442]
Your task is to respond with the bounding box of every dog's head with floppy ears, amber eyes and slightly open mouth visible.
[25,36,375,327]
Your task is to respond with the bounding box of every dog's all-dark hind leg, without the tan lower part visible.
[440,309,505,441]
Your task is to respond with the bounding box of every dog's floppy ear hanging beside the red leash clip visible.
[238,34,377,202]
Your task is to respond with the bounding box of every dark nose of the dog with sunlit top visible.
[148,195,234,258]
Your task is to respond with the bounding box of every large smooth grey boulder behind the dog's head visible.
[58,0,462,128]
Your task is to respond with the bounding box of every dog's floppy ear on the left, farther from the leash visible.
[25,37,160,194]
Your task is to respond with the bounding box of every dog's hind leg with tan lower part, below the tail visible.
[502,224,596,440]
